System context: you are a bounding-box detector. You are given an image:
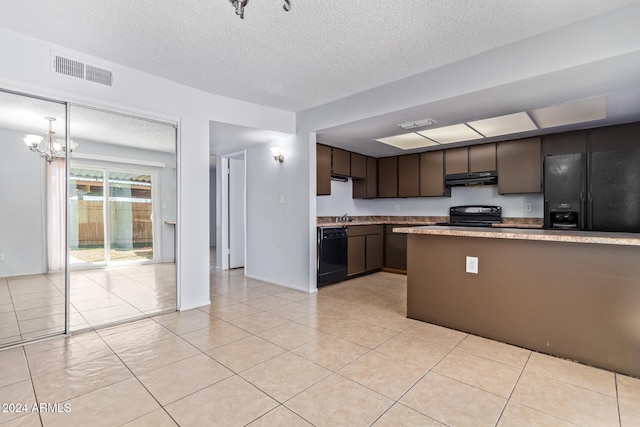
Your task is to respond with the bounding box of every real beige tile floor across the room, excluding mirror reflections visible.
[0,270,640,426]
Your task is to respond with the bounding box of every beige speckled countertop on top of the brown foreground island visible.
[393,226,640,246]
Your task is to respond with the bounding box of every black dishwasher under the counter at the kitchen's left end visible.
[318,227,348,286]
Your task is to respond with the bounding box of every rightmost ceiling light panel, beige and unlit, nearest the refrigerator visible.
[531,96,607,129]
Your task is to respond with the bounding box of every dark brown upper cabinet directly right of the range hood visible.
[498,137,542,194]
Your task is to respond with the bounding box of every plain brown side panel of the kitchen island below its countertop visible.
[407,234,640,376]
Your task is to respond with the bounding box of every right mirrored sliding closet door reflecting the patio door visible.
[69,105,177,331]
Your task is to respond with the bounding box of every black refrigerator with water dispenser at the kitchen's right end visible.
[544,148,640,232]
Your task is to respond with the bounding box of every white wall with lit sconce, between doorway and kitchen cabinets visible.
[245,137,315,291]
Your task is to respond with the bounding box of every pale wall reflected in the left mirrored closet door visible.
[0,129,46,277]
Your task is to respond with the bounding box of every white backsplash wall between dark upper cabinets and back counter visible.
[316,179,544,218]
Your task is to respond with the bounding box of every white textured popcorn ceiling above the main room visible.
[0,0,635,112]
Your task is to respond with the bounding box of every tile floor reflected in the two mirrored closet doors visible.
[0,263,176,346]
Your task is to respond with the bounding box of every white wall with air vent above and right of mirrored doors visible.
[0,29,296,310]
